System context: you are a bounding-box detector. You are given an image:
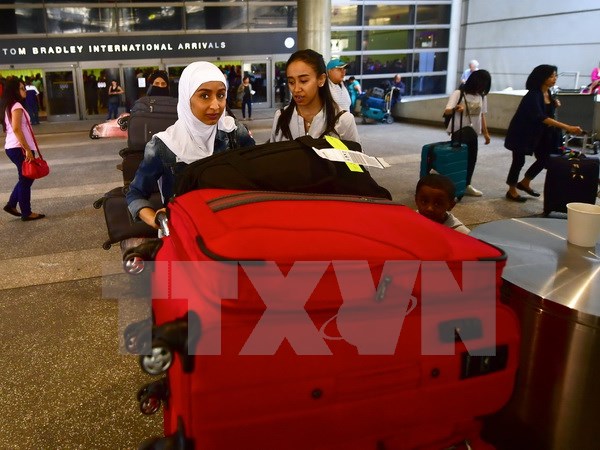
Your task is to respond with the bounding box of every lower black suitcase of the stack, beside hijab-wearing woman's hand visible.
[94,187,163,250]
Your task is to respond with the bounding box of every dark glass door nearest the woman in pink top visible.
[44,69,79,121]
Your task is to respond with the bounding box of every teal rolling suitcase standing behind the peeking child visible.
[420,141,468,200]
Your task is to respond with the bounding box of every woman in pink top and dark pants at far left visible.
[0,77,46,221]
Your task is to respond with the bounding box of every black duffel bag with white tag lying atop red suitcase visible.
[175,136,392,200]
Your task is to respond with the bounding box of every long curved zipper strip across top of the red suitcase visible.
[206,191,403,212]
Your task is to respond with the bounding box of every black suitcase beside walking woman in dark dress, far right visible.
[544,155,600,216]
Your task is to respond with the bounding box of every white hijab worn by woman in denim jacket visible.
[155,61,236,164]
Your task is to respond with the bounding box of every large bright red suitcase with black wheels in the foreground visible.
[134,189,519,450]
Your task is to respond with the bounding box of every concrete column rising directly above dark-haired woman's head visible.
[298,0,331,62]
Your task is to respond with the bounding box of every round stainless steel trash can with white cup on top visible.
[471,218,600,450]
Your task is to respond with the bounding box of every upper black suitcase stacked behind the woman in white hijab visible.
[127,96,177,151]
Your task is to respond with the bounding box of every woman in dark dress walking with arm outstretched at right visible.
[504,64,583,202]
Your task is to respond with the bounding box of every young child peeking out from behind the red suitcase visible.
[415,173,471,234]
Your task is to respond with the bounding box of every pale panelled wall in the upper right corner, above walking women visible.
[458,0,600,91]
